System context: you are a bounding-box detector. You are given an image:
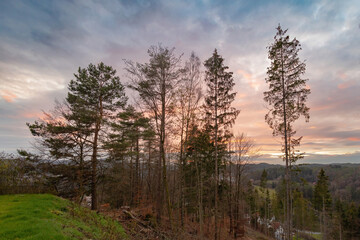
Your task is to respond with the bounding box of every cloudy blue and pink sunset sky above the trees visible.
[0,0,360,163]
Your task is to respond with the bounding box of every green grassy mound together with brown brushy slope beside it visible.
[0,194,271,240]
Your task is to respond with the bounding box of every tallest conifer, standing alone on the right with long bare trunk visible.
[264,25,310,239]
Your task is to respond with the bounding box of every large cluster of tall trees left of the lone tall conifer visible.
[21,45,244,239]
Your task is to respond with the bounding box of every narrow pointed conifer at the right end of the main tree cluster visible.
[204,49,239,240]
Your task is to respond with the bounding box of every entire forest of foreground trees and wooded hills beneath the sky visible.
[0,25,360,240]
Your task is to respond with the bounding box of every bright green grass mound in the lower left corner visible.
[0,194,126,240]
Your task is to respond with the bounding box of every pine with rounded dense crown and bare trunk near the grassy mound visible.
[66,62,127,210]
